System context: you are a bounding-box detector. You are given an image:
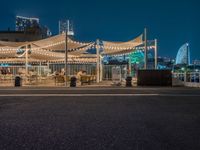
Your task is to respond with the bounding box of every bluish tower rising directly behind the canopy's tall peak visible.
[59,20,74,35]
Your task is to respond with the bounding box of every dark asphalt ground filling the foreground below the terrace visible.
[0,87,200,150]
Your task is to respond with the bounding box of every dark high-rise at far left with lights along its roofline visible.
[16,16,39,31]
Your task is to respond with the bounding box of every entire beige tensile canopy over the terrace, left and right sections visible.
[0,33,155,63]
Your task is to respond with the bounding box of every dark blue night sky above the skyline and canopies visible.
[0,0,200,59]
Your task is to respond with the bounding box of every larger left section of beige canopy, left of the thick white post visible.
[0,34,96,63]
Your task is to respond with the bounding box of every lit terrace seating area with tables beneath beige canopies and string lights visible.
[0,30,157,86]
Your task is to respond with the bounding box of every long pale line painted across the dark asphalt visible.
[0,94,200,97]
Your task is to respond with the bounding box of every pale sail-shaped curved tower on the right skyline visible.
[176,43,190,65]
